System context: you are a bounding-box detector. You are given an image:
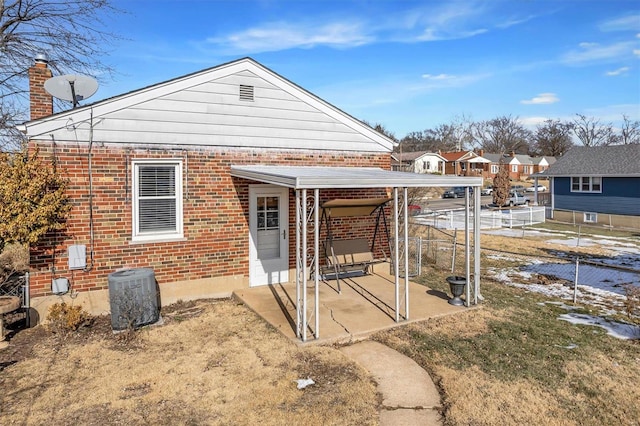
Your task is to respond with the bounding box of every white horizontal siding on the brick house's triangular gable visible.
[34,64,392,153]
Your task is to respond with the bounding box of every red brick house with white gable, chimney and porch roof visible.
[21,58,481,315]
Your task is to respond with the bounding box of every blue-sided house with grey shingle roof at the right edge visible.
[536,145,640,227]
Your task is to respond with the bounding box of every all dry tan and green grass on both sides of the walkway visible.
[0,223,640,426]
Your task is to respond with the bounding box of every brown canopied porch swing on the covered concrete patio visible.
[320,198,392,293]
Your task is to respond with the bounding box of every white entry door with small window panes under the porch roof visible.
[249,185,289,287]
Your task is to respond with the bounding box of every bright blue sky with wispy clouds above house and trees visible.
[99,0,640,138]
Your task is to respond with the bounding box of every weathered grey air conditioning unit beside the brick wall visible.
[109,268,160,330]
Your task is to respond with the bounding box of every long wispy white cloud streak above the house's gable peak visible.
[199,0,537,54]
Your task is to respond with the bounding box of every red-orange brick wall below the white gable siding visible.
[31,142,390,297]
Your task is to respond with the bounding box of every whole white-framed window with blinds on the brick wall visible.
[133,160,183,241]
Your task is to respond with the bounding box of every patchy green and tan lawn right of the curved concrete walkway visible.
[374,220,640,426]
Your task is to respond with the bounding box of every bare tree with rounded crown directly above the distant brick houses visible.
[472,115,532,154]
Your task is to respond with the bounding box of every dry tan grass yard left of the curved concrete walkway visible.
[0,300,380,425]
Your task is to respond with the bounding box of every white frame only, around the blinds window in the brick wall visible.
[131,158,184,242]
